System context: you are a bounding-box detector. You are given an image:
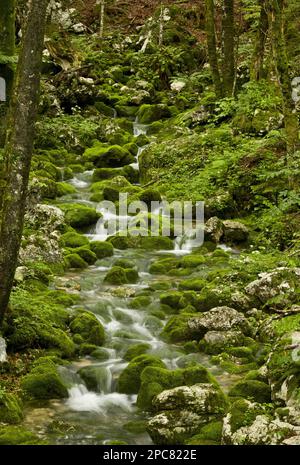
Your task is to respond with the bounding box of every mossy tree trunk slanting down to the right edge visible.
[267,0,299,154]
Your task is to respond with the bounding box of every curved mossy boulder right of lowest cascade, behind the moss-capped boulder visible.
[117,355,165,394]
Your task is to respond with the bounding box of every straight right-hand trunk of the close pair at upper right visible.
[222,0,235,97]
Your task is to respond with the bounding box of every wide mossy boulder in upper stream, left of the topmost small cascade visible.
[83,144,135,168]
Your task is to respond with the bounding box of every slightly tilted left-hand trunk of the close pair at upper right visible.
[205,0,222,98]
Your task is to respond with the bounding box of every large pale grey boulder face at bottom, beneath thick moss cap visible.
[148,384,226,444]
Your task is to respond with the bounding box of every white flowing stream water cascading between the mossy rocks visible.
[22,123,240,444]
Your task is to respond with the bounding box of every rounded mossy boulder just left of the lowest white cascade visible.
[21,357,68,399]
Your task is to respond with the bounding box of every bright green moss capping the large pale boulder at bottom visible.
[137,365,218,410]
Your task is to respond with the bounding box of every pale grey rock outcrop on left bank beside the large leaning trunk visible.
[19,204,65,263]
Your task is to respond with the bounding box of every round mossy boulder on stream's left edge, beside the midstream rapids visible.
[70,310,105,346]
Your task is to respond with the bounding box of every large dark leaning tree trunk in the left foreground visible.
[0,0,48,324]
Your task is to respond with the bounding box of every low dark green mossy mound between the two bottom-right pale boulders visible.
[228,380,271,403]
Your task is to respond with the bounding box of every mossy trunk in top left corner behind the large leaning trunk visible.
[0,0,15,147]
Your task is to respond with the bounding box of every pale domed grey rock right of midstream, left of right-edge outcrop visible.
[188,307,251,337]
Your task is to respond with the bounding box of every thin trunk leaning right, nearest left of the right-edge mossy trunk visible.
[251,0,269,81]
